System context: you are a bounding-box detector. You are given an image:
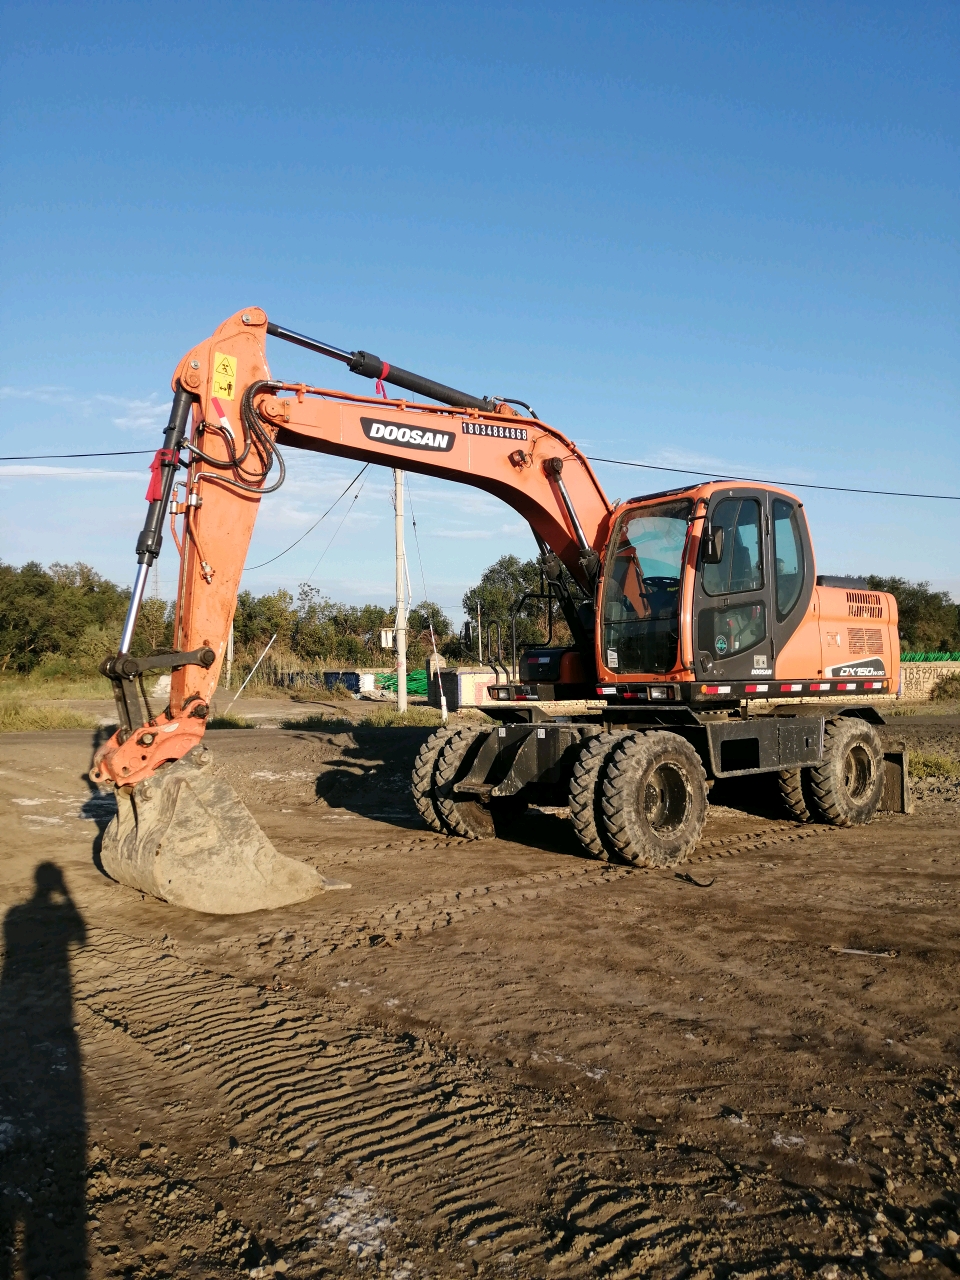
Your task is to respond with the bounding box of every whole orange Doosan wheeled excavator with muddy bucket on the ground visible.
[91,307,908,913]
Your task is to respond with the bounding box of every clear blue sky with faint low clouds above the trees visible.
[0,0,960,618]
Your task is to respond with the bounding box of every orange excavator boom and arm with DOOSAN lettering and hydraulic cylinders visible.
[91,307,612,910]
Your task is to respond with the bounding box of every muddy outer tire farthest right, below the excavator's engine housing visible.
[810,716,883,827]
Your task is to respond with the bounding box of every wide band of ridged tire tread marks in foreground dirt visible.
[69,929,757,1276]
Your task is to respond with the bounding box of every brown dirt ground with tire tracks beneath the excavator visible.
[0,714,960,1280]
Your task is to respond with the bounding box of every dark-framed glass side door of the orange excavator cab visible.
[692,488,774,681]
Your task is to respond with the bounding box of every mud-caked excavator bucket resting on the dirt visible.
[100,745,349,915]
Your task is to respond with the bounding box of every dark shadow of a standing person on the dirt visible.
[0,863,87,1280]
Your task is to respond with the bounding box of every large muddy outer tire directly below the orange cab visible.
[603,731,707,867]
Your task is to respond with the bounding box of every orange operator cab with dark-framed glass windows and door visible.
[596,484,819,701]
